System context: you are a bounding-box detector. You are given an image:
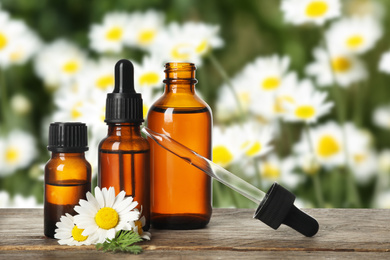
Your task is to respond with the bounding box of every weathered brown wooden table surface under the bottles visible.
[0,209,390,259]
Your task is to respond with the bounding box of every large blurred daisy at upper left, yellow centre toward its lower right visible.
[35,39,87,87]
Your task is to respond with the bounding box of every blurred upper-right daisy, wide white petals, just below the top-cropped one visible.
[326,16,383,54]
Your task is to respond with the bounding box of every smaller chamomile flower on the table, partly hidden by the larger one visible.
[54,213,94,246]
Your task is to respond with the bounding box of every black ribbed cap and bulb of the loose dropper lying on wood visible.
[253,183,319,237]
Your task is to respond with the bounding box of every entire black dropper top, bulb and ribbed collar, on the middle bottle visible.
[104,59,144,123]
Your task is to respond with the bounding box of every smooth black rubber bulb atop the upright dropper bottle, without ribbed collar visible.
[112,59,135,94]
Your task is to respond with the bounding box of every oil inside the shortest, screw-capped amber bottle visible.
[44,180,91,238]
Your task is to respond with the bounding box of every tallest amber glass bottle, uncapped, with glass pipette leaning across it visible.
[147,63,212,229]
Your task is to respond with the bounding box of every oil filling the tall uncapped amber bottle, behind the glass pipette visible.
[148,106,212,229]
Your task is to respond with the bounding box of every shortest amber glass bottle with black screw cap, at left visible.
[44,123,91,238]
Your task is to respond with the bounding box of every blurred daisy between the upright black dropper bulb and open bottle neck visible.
[134,56,165,89]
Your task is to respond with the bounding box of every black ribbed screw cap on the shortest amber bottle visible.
[47,122,88,153]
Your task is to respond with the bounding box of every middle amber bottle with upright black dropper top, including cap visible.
[98,60,150,230]
